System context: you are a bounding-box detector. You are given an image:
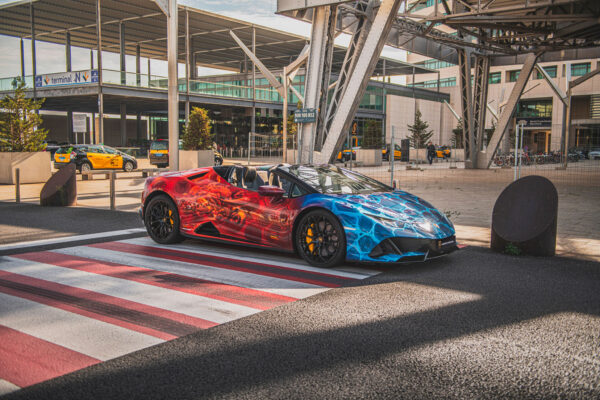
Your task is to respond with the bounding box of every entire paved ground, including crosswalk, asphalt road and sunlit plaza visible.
[0,158,600,399]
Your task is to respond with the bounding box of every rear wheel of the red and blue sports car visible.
[144,195,184,244]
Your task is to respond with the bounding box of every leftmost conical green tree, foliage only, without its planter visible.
[0,77,48,152]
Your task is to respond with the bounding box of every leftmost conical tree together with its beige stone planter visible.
[0,78,51,184]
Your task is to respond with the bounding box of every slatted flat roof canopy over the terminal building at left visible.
[0,0,433,76]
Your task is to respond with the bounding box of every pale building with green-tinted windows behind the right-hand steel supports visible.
[407,0,600,153]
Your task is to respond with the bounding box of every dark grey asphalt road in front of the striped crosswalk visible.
[6,247,600,400]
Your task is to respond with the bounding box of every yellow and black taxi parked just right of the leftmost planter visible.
[54,144,137,172]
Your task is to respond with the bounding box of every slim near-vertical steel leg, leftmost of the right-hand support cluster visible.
[457,49,477,168]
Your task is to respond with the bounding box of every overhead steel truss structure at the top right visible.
[277,0,600,65]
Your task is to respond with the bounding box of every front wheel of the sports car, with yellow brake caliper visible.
[295,209,346,268]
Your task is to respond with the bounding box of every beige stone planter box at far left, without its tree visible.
[0,151,52,185]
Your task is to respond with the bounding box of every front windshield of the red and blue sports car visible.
[285,165,392,194]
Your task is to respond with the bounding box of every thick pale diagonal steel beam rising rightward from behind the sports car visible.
[319,0,402,162]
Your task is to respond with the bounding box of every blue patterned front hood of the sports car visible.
[336,190,455,238]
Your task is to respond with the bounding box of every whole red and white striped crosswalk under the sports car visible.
[0,238,379,395]
